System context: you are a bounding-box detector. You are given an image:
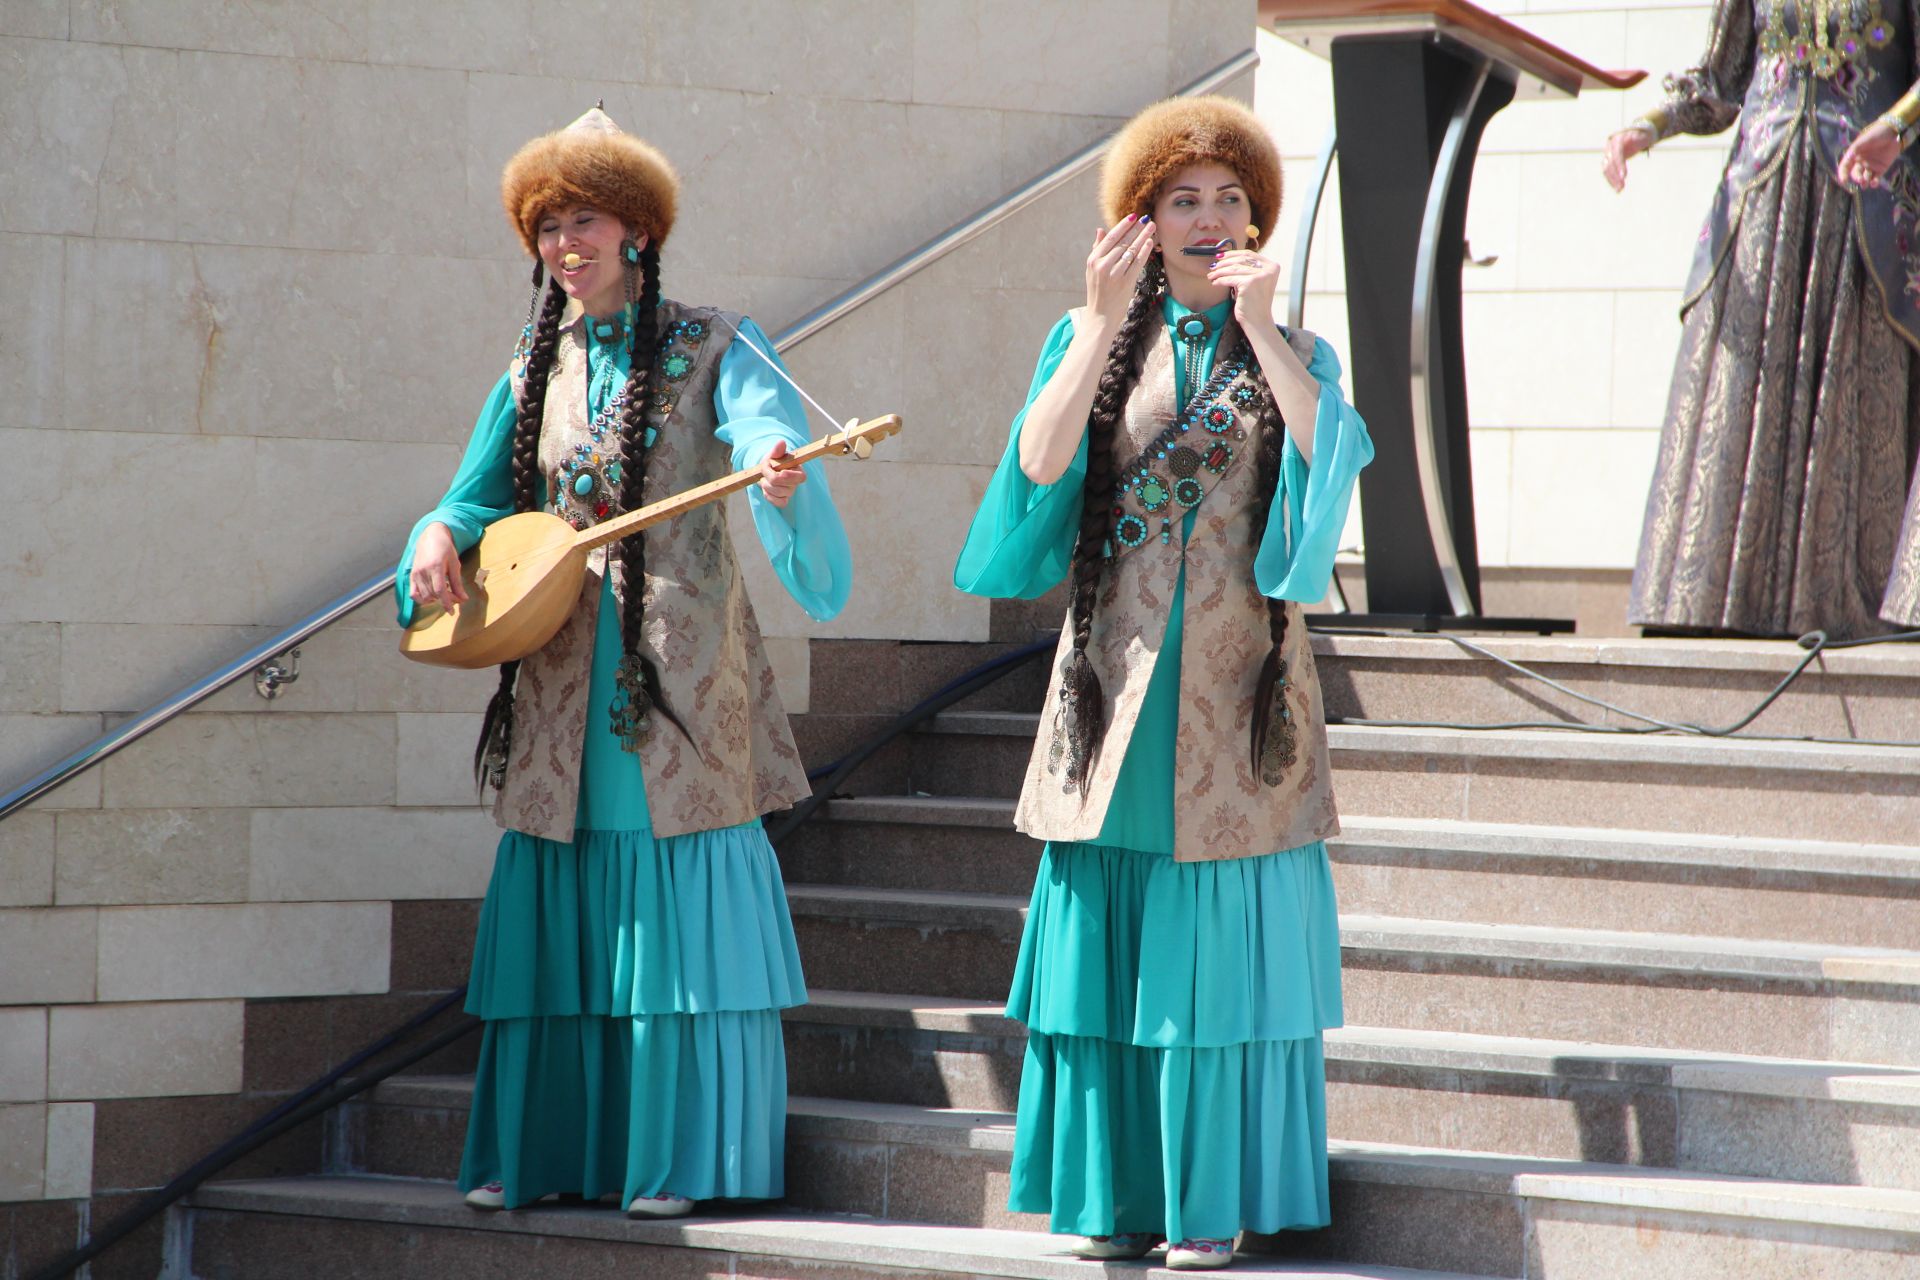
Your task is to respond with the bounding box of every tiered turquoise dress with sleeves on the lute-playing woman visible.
[397,320,852,1205]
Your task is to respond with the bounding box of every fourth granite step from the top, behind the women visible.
[787,885,1920,1065]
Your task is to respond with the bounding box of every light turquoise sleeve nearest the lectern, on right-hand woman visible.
[1254,340,1373,604]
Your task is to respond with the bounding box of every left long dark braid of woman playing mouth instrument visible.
[1048,257,1167,794]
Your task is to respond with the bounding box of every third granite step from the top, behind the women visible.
[780,796,1920,946]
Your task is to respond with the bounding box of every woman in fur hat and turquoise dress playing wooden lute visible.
[399,109,851,1217]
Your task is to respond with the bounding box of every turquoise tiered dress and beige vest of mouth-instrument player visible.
[954,299,1373,1240]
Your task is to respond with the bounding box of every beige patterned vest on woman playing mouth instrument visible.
[1016,313,1340,862]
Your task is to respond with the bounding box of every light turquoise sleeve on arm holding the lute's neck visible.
[714,319,852,622]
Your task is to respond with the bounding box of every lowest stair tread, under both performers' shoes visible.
[194,1174,1476,1280]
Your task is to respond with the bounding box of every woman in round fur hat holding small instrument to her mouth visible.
[954,98,1373,1268]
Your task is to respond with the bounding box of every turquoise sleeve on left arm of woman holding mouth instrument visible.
[954,317,1087,601]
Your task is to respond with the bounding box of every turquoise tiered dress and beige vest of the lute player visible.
[399,303,852,1207]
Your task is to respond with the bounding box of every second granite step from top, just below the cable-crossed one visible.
[906,712,1920,844]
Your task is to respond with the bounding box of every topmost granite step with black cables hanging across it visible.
[1313,631,1920,745]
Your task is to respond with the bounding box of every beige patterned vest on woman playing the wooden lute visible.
[493,301,808,841]
